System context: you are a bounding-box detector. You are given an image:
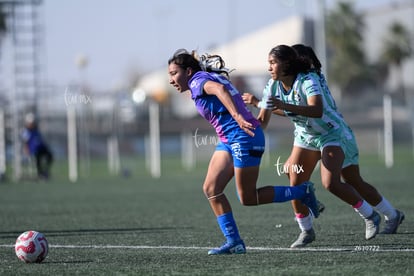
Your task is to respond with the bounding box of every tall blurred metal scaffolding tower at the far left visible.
[0,0,44,180]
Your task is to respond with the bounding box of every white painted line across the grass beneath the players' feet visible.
[0,244,414,252]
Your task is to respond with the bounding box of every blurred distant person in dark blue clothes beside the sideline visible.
[22,113,53,179]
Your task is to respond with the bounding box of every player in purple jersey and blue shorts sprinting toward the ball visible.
[168,49,318,255]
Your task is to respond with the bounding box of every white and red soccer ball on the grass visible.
[14,230,49,263]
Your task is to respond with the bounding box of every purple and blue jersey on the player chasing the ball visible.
[189,71,260,143]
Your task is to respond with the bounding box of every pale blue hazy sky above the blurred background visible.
[43,0,392,90]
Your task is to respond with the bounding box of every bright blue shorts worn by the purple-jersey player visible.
[216,127,265,168]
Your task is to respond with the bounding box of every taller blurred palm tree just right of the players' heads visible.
[326,2,371,96]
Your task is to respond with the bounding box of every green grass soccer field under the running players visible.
[0,150,414,275]
